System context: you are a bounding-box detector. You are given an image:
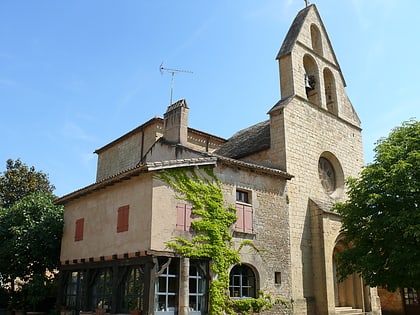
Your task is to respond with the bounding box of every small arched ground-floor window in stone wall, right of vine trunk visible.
[229,265,256,298]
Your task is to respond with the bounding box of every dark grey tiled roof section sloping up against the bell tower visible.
[214,120,270,159]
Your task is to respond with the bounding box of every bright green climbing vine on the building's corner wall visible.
[157,167,283,314]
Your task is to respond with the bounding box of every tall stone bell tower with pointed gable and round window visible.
[269,4,380,314]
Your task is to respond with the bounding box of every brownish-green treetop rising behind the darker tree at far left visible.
[0,159,55,208]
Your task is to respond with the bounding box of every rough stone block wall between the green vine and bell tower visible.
[216,165,292,301]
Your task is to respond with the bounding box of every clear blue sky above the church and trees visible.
[0,0,420,196]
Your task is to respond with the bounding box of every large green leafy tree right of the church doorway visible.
[335,120,420,290]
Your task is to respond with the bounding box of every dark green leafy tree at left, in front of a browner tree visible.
[0,192,63,312]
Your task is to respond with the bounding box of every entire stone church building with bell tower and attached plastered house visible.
[57,4,381,315]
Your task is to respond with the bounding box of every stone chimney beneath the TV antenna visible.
[163,99,189,145]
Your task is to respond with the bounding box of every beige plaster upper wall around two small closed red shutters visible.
[60,174,152,262]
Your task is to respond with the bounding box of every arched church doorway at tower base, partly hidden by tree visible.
[332,240,370,312]
